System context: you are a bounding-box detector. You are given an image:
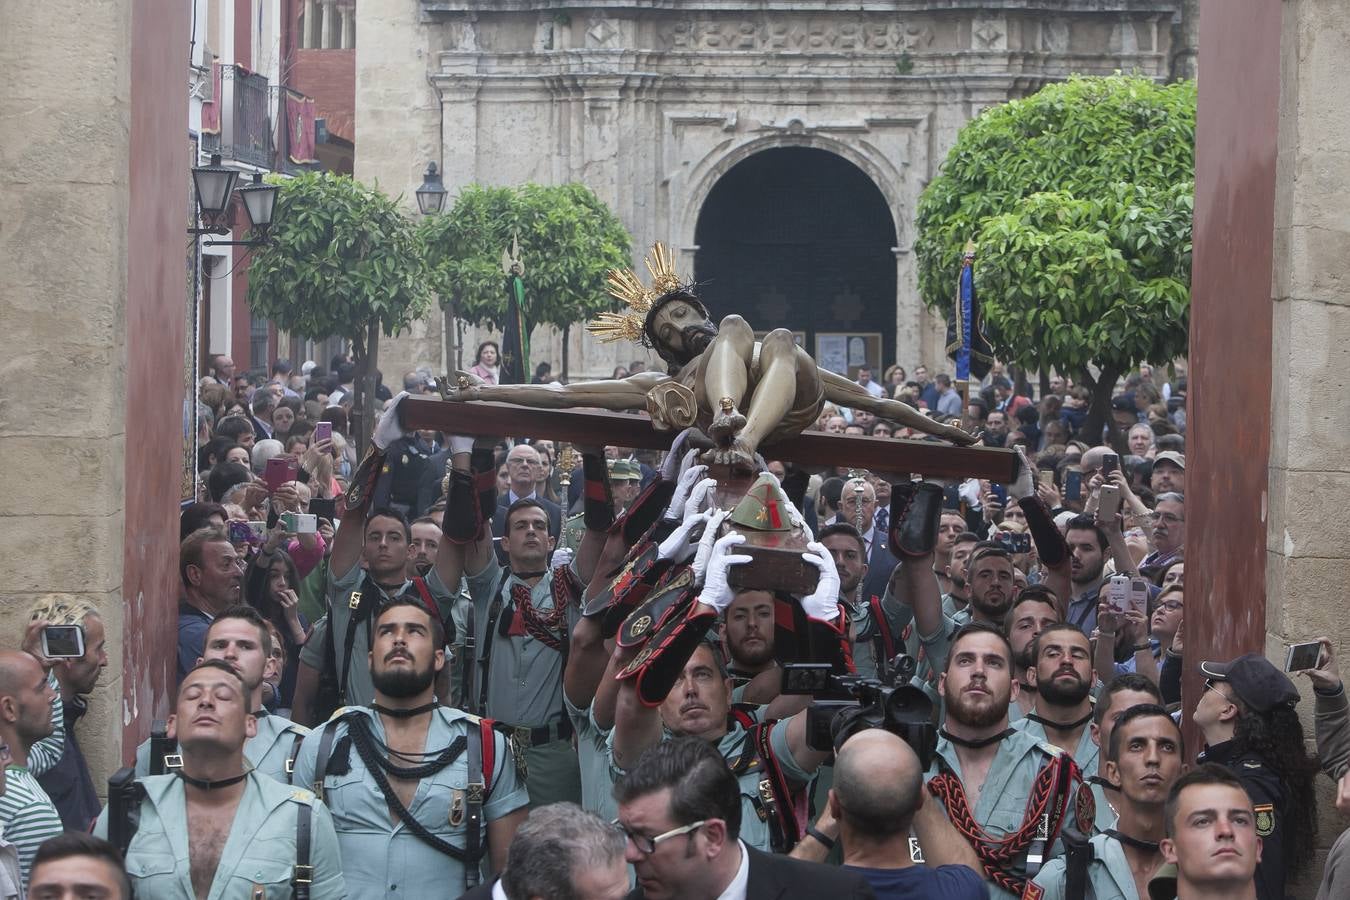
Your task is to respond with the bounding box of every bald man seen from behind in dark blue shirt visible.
[829,729,986,900]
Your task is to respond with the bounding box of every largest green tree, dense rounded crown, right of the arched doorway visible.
[915,76,1196,440]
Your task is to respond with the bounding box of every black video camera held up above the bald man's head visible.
[782,653,937,770]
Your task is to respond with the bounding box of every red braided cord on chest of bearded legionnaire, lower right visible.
[927,756,1068,896]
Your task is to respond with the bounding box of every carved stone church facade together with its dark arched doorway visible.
[355,0,1196,378]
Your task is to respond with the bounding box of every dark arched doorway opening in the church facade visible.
[694,147,896,379]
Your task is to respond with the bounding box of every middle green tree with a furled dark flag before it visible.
[420,184,632,376]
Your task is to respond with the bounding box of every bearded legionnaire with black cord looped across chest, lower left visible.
[296,599,527,900]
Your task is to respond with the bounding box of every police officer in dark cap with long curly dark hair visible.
[1195,653,1318,900]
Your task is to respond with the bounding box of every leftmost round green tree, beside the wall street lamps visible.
[248,173,431,452]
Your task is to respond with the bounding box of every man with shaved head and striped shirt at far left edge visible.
[0,621,66,881]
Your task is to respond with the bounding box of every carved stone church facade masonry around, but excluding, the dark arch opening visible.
[356,0,1187,376]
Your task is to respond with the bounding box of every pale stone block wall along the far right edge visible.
[1269,0,1350,897]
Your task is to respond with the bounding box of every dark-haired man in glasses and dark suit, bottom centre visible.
[614,737,873,900]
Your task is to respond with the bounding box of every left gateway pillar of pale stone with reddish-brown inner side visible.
[0,0,192,784]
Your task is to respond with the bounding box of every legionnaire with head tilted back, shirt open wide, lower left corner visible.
[95,660,347,900]
